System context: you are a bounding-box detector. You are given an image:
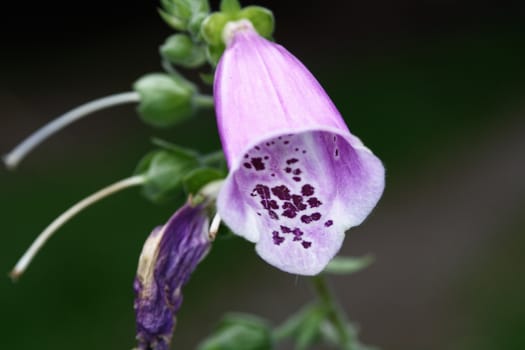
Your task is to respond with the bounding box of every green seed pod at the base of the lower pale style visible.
[136,150,199,202]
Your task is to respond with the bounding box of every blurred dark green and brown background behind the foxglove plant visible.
[0,0,525,350]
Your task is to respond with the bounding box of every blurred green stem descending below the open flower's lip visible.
[311,274,355,350]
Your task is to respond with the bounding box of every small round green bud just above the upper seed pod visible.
[160,34,206,68]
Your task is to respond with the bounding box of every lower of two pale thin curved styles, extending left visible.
[9,176,145,280]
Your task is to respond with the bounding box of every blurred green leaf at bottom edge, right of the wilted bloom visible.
[197,314,274,350]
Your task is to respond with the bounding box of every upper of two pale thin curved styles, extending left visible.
[3,91,140,169]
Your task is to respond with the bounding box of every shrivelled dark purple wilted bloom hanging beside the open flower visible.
[134,204,210,350]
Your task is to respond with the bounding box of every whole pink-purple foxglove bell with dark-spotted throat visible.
[214,20,384,275]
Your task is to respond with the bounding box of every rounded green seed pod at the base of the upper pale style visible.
[133,73,195,127]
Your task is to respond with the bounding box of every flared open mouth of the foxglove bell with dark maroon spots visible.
[217,131,384,275]
